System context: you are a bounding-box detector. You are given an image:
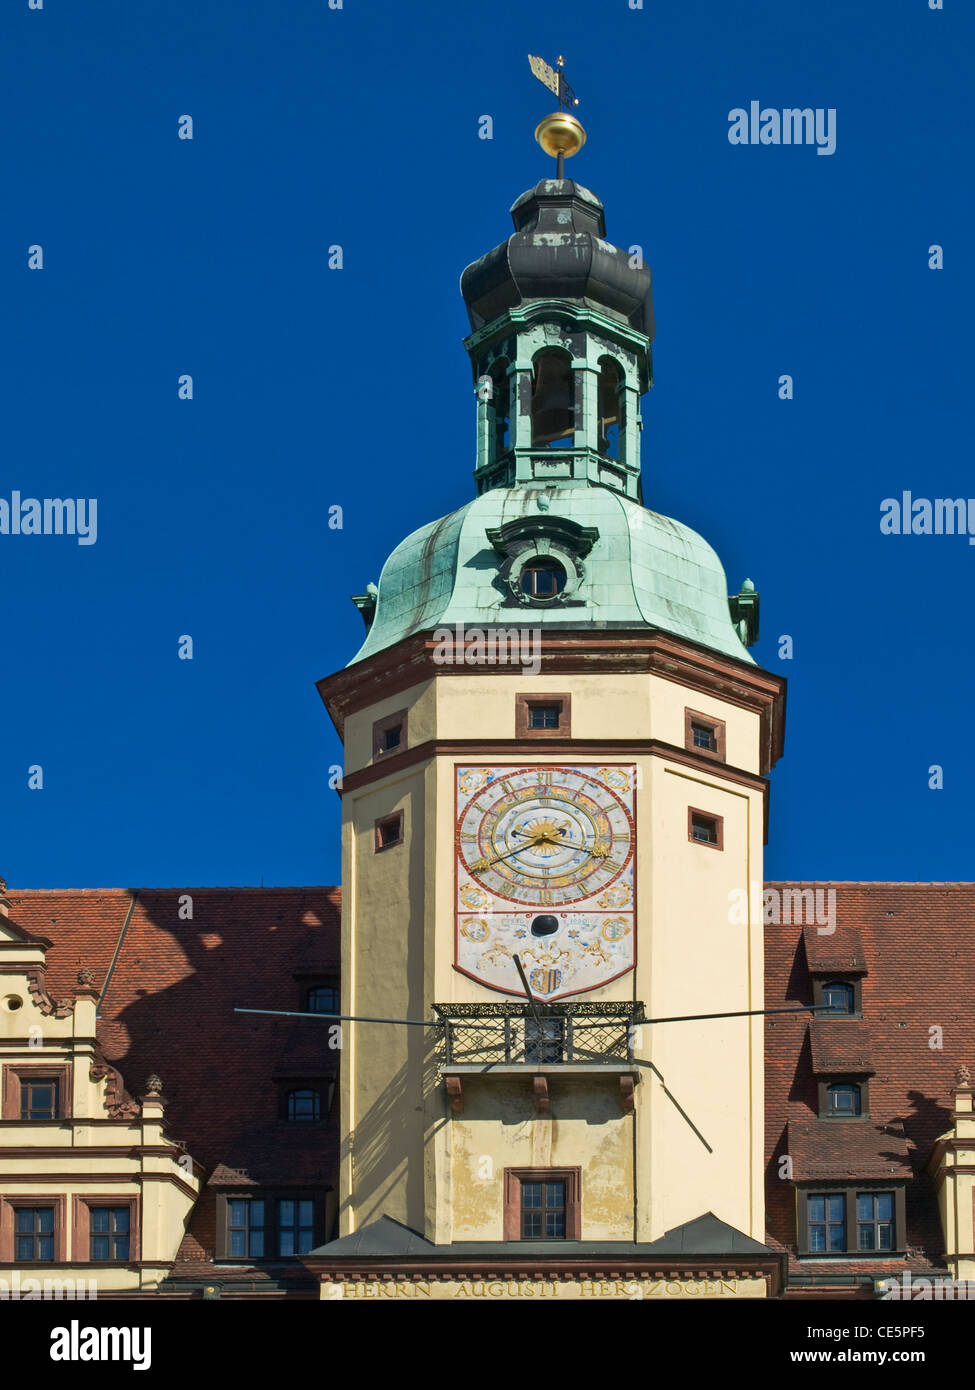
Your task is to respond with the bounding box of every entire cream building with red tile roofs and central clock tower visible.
[0,143,975,1302]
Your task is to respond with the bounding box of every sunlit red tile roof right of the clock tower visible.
[765,883,975,1273]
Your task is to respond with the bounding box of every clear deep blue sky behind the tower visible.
[0,0,975,887]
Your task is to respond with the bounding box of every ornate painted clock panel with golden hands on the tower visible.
[455,763,636,999]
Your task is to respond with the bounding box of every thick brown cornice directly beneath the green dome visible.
[317,628,786,773]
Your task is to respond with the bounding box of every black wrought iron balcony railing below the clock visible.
[434,1001,644,1068]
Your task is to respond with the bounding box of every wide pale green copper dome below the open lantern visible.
[349,482,754,664]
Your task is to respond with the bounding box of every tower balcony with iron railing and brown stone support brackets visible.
[434,1001,644,1115]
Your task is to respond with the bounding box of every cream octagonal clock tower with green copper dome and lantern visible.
[315,100,784,1300]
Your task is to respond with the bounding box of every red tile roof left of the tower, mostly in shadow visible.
[10,887,339,1284]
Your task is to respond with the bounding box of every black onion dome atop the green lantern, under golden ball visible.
[460,178,654,342]
